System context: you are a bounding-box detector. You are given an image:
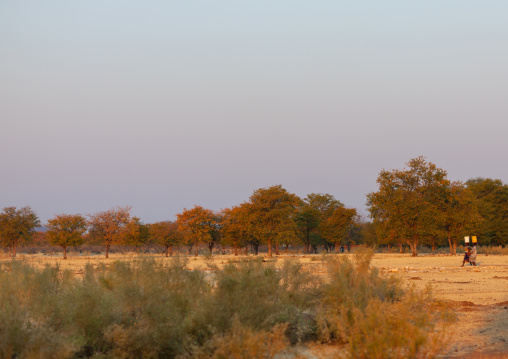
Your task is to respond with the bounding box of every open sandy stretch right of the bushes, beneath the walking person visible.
[372,254,508,358]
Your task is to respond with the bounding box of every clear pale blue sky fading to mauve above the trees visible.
[0,0,508,223]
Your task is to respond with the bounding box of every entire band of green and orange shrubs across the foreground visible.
[0,251,449,358]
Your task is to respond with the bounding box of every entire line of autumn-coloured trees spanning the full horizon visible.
[0,157,508,258]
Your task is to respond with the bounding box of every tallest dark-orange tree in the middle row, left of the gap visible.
[249,185,300,257]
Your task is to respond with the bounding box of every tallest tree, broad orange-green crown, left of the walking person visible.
[367,156,450,256]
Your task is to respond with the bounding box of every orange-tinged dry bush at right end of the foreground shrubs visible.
[318,251,453,358]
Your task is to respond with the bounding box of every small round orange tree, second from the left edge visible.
[46,214,88,259]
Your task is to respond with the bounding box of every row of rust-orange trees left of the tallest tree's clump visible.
[0,185,358,259]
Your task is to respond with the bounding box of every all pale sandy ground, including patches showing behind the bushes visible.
[0,254,508,358]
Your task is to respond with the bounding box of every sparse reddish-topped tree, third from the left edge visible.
[88,206,131,258]
